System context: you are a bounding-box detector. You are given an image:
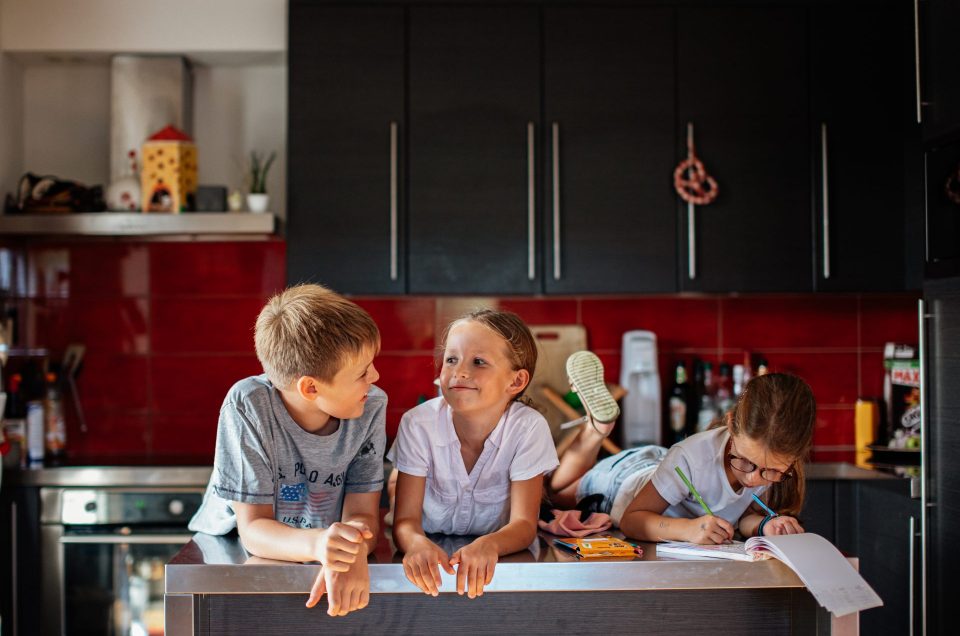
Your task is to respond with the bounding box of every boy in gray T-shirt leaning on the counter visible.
[190,285,387,616]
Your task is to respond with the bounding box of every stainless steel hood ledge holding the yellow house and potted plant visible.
[0,212,276,236]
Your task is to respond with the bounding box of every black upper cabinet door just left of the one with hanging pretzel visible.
[543,7,677,293]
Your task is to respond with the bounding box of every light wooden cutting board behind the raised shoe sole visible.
[527,325,587,442]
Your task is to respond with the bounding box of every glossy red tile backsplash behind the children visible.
[0,240,917,461]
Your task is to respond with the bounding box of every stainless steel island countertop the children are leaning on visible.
[165,534,824,595]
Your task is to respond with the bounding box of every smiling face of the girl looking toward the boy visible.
[440,321,529,417]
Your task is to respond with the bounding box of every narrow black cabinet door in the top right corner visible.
[913,0,960,140]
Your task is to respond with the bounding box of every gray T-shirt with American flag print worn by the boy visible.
[189,375,387,534]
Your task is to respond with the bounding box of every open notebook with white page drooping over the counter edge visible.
[657,532,883,616]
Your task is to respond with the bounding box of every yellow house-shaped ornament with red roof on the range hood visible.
[140,126,197,213]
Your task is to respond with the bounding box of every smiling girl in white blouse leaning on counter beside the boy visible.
[387,309,558,598]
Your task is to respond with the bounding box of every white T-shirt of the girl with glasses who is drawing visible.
[651,426,767,527]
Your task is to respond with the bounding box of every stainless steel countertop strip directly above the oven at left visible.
[3,465,213,488]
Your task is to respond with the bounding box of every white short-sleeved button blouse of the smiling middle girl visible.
[387,397,559,535]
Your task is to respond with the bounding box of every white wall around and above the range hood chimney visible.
[0,0,287,217]
